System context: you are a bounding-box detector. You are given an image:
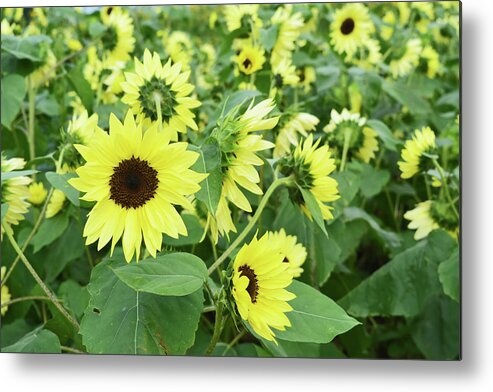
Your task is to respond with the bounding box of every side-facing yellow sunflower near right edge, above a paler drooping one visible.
[397,127,435,179]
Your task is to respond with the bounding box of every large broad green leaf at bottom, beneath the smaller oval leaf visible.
[80,259,204,354]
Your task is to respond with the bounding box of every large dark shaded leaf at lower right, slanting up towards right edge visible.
[339,231,453,317]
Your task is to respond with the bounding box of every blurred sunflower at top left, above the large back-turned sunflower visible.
[100,7,135,68]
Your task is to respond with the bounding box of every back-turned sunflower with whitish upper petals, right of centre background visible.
[323,109,378,163]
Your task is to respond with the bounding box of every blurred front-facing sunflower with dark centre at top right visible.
[330,3,374,59]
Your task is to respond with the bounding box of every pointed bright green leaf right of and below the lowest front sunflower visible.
[276,280,359,343]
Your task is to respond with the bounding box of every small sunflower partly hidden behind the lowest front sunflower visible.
[268,229,307,278]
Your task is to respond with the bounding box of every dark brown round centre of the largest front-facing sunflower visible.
[110,157,159,209]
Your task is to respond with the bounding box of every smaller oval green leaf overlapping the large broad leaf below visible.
[114,253,207,296]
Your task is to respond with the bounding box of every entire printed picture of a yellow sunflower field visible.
[1,1,460,360]
